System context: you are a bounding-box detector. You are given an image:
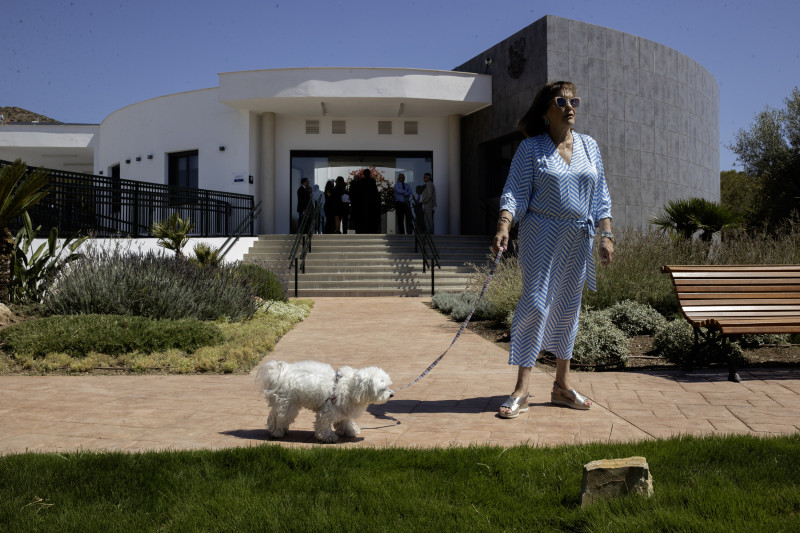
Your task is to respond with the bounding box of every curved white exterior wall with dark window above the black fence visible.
[94,89,255,198]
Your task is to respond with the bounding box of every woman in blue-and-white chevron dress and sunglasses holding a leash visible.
[492,81,614,418]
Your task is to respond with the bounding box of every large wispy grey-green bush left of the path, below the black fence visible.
[43,244,258,320]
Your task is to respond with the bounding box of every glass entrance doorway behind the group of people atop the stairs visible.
[289,150,433,233]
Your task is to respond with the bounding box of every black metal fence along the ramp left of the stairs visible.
[0,160,254,237]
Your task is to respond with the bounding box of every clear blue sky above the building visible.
[0,0,800,170]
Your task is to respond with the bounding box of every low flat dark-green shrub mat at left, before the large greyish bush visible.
[0,315,223,357]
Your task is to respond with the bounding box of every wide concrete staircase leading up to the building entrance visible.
[244,234,491,298]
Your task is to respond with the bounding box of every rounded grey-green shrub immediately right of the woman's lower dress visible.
[572,311,628,367]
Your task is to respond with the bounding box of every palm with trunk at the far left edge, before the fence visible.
[0,159,50,304]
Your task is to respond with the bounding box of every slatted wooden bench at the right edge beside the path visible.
[661,265,800,383]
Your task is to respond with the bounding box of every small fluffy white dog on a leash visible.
[256,361,394,442]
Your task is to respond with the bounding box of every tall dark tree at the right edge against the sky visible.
[729,87,800,227]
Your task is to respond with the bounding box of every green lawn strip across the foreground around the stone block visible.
[0,436,800,532]
